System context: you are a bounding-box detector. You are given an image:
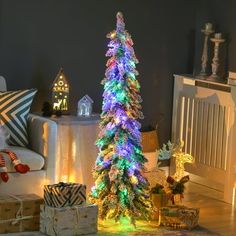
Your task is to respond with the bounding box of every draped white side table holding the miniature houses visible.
[50,114,100,193]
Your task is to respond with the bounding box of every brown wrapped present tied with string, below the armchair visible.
[0,194,43,233]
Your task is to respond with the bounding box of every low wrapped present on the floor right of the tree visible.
[159,205,199,229]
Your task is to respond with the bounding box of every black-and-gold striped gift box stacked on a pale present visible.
[44,182,86,207]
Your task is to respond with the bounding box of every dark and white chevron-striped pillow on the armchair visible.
[0,89,37,147]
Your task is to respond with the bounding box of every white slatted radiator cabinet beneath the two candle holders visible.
[172,75,236,203]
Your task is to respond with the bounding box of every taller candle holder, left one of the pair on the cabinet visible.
[198,23,214,79]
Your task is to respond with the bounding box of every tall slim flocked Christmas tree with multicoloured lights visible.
[91,12,150,224]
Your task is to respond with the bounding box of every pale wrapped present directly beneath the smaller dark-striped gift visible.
[40,205,98,236]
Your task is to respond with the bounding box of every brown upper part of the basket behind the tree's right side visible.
[141,130,160,152]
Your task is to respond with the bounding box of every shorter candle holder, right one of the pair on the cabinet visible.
[207,33,225,82]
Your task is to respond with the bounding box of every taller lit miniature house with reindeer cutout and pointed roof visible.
[52,68,69,112]
